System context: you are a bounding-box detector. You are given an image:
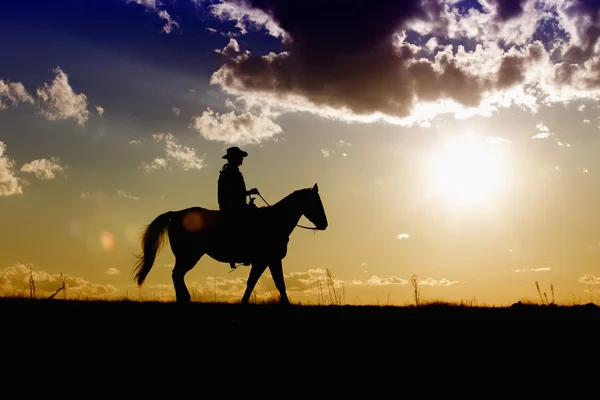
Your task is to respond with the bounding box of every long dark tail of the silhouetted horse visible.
[134,211,171,287]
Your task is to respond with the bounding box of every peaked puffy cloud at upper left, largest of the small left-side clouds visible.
[37,67,89,126]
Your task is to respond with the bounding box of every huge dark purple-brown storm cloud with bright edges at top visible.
[210,0,536,117]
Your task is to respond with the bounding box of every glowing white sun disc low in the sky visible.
[428,135,506,206]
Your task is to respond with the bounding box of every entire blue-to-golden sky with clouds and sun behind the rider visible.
[0,0,600,305]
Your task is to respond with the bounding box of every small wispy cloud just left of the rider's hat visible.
[140,133,204,172]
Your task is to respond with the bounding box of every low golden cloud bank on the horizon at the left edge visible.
[0,263,117,298]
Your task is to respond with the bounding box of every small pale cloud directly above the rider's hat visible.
[190,108,283,145]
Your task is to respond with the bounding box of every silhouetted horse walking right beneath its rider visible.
[134,183,328,304]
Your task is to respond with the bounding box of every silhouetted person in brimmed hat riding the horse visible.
[218,147,260,268]
